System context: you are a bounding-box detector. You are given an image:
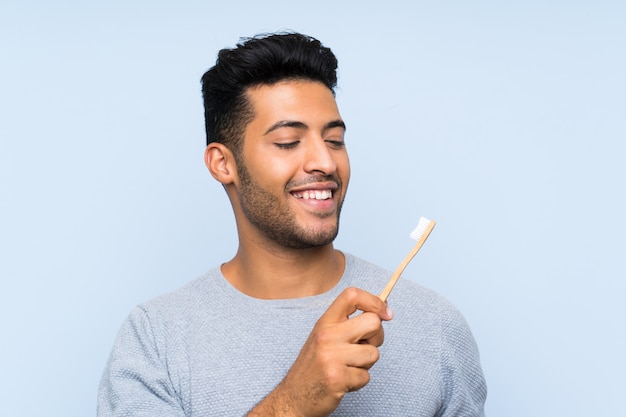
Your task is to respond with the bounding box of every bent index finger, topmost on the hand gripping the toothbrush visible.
[322,287,392,322]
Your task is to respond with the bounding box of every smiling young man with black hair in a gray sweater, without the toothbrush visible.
[98,33,486,417]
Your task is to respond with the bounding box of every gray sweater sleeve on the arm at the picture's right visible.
[439,307,487,417]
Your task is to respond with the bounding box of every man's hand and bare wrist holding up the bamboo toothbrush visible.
[248,288,392,416]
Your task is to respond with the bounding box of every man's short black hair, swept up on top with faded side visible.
[202,33,337,150]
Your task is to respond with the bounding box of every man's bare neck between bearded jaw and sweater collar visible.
[222,241,345,299]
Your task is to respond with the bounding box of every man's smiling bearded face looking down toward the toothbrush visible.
[237,81,350,249]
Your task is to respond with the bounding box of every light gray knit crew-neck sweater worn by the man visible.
[98,255,486,417]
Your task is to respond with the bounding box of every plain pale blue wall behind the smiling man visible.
[0,0,626,417]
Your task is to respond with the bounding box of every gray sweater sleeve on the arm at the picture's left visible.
[97,307,185,417]
